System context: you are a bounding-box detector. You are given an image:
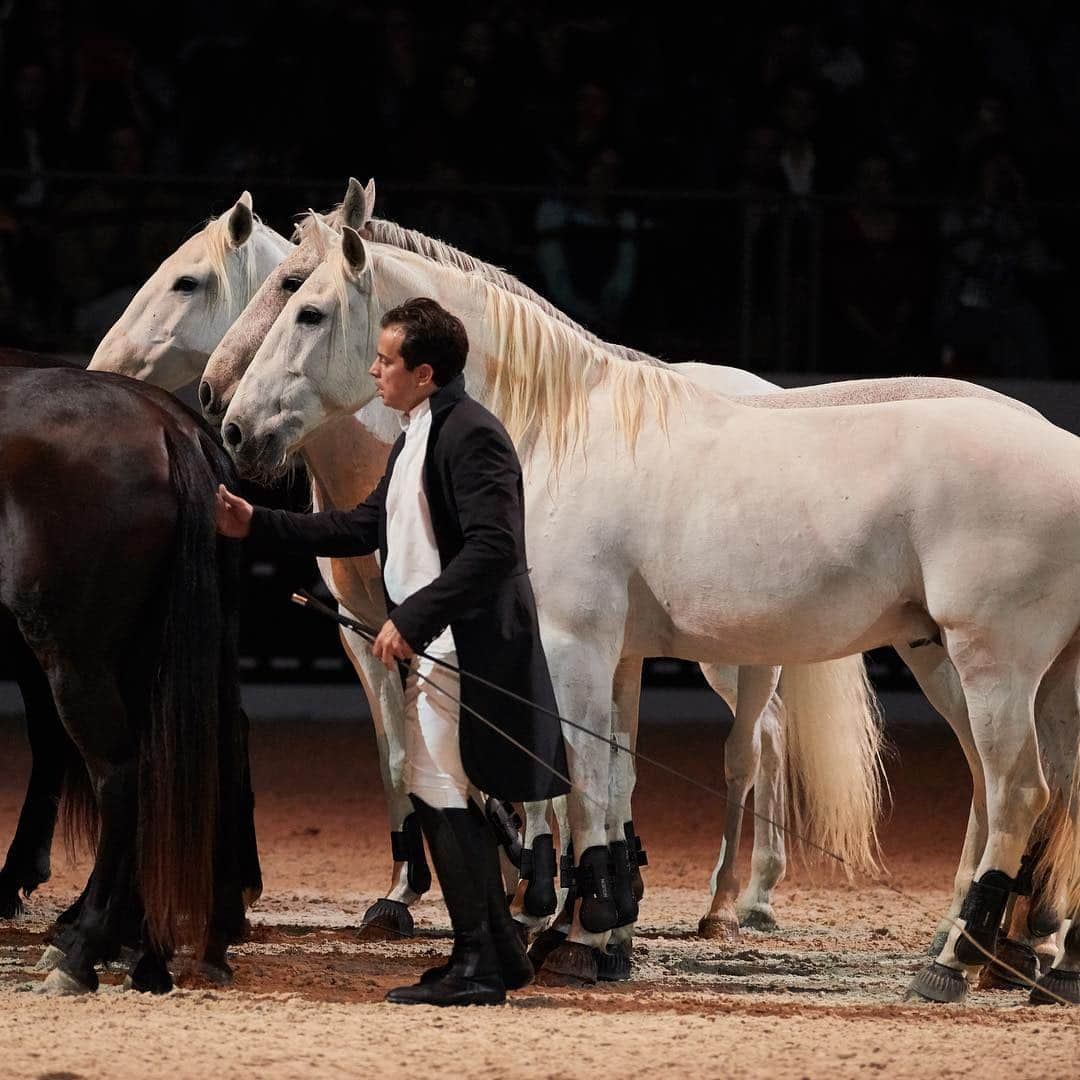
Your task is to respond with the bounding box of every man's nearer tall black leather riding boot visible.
[387,795,507,1005]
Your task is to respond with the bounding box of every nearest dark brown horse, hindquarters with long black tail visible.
[0,365,251,989]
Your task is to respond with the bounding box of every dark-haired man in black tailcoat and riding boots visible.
[217,298,567,1005]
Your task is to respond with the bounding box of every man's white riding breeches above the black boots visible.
[405,649,469,810]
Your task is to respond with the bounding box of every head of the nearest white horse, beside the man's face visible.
[221,227,416,477]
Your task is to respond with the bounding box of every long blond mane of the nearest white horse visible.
[327,245,701,465]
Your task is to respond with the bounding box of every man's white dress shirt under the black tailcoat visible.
[382,399,454,656]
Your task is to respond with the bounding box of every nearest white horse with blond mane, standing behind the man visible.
[222,229,1080,997]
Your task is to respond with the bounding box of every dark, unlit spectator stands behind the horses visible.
[0,0,1080,678]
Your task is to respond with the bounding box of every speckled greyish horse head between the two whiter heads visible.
[199,179,375,423]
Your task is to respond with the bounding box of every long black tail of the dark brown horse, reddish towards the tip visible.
[138,420,235,949]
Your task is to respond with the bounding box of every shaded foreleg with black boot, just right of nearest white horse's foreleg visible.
[597,657,645,982]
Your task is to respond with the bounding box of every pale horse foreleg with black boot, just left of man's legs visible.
[341,627,431,941]
